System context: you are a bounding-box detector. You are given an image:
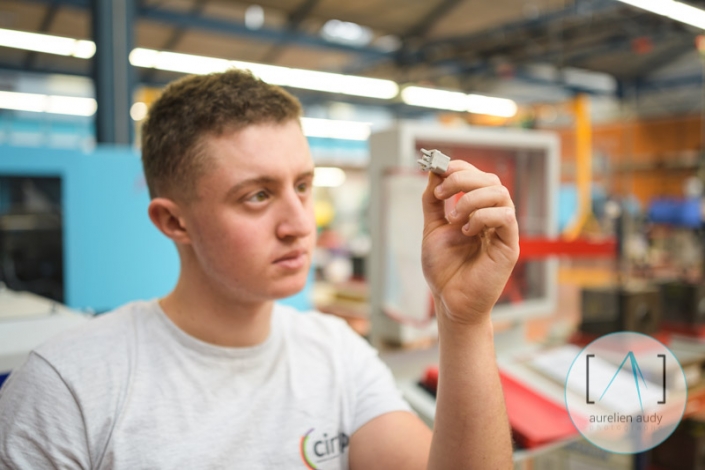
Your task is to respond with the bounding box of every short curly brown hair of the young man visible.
[142,69,301,201]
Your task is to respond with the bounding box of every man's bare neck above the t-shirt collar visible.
[159,272,274,347]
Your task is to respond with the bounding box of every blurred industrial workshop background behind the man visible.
[0,0,705,470]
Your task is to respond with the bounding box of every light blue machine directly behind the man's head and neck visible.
[0,146,312,312]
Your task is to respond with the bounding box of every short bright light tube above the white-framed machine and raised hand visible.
[401,86,517,117]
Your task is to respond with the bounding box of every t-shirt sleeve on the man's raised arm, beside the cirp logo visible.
[348,330,412,433]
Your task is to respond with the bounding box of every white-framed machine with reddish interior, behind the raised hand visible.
[368,122,560,344]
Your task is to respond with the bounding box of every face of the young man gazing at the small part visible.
[184,121,316,302]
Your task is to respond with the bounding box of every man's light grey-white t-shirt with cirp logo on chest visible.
[0,300,410,470]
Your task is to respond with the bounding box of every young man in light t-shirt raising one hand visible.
[0,70,518,470]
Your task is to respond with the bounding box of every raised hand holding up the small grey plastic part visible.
[422,160,519,324]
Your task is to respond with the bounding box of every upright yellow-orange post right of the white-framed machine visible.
[563,94,592,240]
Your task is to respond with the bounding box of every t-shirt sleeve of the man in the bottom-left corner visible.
[0,353,90,470]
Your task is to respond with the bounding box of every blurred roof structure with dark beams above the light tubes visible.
[0,0,705,130]
